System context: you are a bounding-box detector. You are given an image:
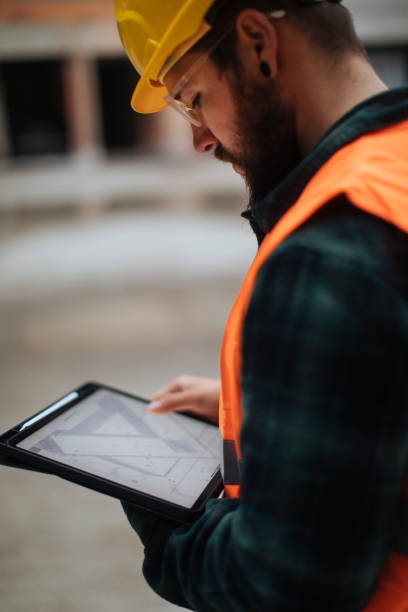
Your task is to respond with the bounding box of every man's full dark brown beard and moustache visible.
[214,77,301,208]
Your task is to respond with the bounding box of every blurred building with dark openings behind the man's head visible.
[0,0,408,211]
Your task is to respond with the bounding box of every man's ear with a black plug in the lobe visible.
[235,9,278,80]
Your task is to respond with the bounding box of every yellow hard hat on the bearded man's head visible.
[115,0,215,113]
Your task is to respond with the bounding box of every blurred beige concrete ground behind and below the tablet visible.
[0,208,255,612]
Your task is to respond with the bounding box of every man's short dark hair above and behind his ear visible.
[192,0,365,70]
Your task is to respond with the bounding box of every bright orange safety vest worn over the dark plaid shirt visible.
[220,121,408,612]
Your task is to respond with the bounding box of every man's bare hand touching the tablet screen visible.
[149,375,220,425]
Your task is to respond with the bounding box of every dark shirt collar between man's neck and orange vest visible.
[242,87,408,243]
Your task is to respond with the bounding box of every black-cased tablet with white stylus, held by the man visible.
[0,383,222,522]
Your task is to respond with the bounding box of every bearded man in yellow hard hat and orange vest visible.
[116,0,408,612]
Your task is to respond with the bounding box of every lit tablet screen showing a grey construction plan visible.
[16,388,219,508]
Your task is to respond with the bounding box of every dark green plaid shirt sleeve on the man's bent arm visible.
[121,239,408,612]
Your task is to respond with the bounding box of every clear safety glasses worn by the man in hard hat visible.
[164,10,287,127]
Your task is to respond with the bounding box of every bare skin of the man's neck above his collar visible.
[295,54,387,156]
